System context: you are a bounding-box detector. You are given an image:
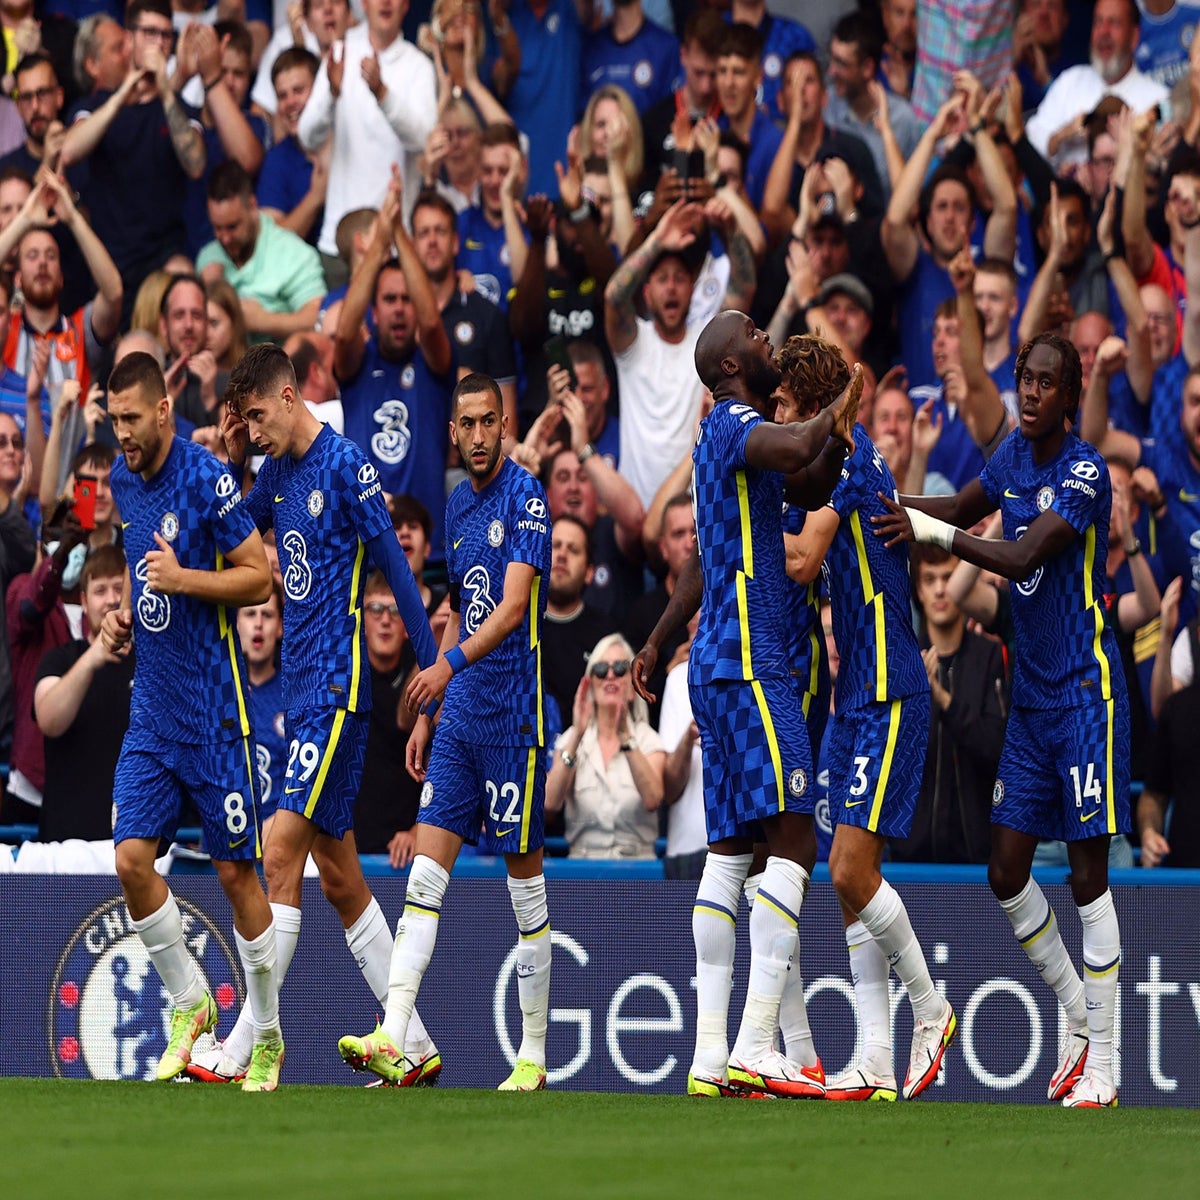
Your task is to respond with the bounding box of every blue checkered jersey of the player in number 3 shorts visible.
[823,425,929,712]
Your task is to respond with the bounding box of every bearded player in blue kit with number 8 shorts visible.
[102,353,283,1091]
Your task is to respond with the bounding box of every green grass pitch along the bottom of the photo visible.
[0,1079,1200,1200]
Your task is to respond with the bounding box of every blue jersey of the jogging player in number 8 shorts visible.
[112,438,254,744]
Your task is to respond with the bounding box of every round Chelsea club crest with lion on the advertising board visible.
[46,896,242,1079]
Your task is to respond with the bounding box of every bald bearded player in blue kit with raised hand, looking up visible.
[634,311,863,1097]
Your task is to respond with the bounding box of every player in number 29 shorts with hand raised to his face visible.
[190,343,442,1085]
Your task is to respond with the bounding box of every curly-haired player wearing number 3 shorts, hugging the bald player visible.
[780,340,958,1100]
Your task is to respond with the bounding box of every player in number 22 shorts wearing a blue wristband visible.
[337,374,551,1092]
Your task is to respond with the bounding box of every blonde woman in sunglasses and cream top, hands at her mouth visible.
[546,634,666,858]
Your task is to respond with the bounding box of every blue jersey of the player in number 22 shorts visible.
[442,460,550,746]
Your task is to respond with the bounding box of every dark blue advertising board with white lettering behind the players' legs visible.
[0,859,1200,1106]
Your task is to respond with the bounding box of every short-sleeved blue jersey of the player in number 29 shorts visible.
[247,425,391,713]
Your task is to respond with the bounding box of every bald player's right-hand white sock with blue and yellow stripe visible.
[733,856,808,1062]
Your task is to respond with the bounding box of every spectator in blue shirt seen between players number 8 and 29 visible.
[238,584,288,845]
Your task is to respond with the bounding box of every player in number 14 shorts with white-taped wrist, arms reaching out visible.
[878,334,1129,1108]
